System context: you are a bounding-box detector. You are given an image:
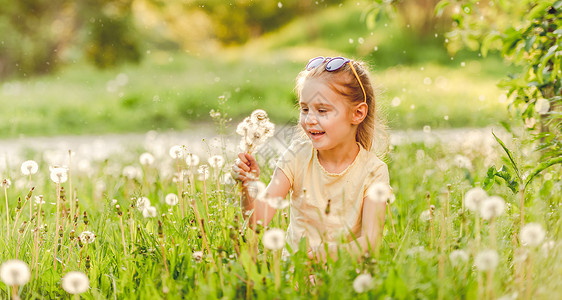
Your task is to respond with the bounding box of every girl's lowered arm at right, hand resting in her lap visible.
[308,197,386,260]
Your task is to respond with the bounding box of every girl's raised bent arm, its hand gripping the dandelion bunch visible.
[233,153,291,227]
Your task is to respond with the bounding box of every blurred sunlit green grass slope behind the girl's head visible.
[0,0,512,138]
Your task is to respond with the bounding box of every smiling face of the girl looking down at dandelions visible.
[299,78,362,150]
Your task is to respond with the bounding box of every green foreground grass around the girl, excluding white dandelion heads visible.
[0,128,562,299]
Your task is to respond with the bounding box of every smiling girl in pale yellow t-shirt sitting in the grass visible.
[233,57,389,259]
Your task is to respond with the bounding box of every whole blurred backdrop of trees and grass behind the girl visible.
[0,0,517,138]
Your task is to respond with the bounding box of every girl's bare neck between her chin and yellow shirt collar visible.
[318,142,361,173]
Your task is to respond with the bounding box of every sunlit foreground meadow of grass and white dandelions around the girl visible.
[0,112,562,299]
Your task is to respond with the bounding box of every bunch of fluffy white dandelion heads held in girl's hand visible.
[236,109,275,153]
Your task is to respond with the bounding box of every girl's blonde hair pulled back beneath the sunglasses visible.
[295,60,388,156]
